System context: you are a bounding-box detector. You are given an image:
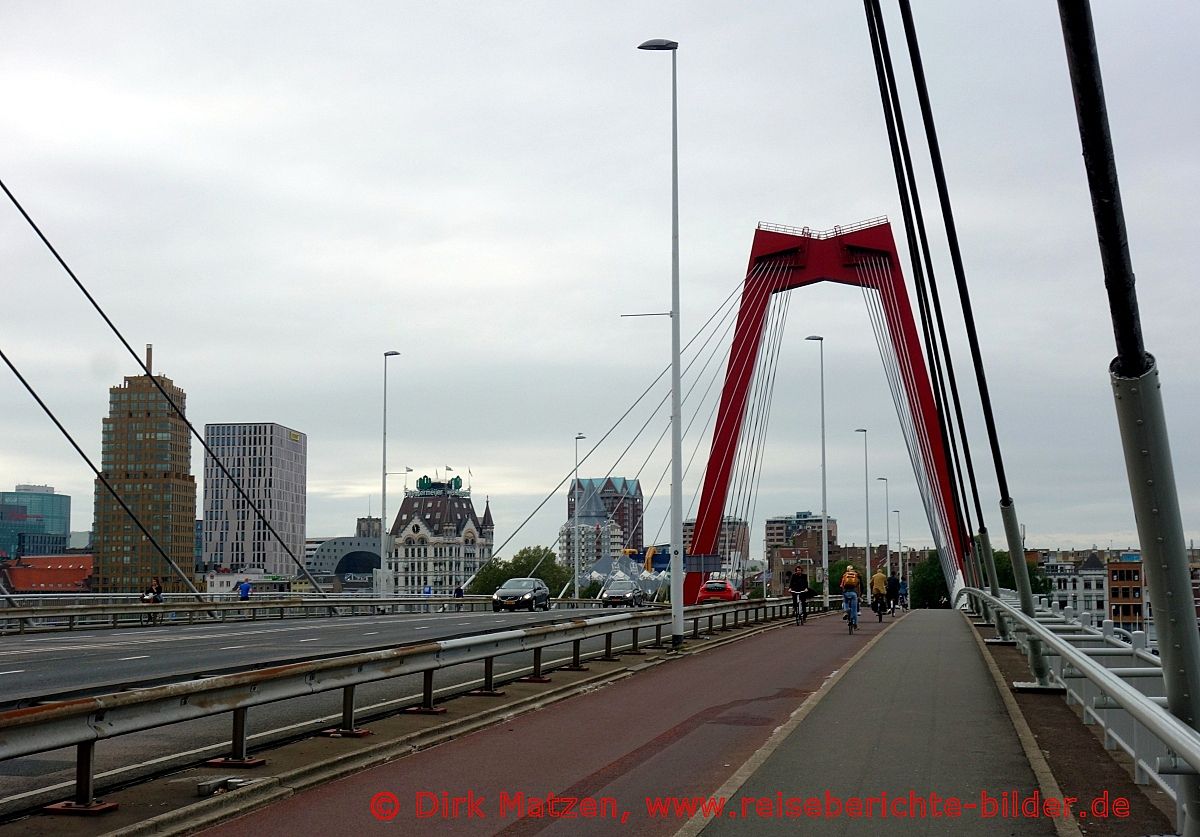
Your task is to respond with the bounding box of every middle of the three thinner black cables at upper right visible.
[876,0,998,595]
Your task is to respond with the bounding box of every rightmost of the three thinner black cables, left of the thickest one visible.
[878,0,1049,666]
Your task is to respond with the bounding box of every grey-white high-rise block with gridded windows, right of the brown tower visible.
[203,423,308,577]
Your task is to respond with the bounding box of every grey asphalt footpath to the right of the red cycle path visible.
[679,610,1056,837]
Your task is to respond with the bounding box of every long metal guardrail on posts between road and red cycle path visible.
[0,598,791,812]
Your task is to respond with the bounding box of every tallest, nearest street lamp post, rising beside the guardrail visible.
[637,38,683,649]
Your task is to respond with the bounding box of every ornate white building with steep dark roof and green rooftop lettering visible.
[386,476,496,596]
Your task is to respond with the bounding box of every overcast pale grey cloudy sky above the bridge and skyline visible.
[0,0,1200,561]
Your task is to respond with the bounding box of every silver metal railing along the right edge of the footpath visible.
[956,588,1200,830]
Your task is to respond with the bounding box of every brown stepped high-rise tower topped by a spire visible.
[92,347,196,592]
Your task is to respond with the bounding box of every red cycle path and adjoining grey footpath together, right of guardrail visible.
[196,610,1055,837]
